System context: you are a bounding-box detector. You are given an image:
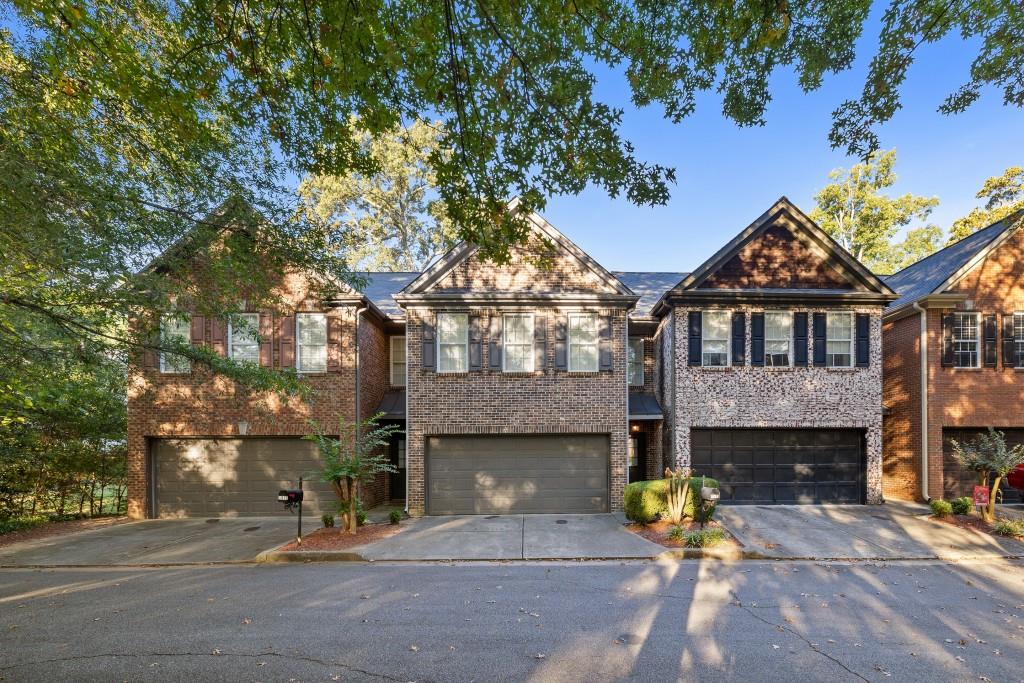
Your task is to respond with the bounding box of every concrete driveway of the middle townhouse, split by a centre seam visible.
[359,514,665,560]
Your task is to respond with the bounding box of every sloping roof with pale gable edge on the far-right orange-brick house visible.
[885,211,1024,311]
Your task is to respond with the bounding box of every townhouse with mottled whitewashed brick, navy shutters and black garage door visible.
[653,198,896,504]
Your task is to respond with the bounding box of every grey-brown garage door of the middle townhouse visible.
[427,435,610,515]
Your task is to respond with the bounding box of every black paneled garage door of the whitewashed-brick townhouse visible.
[690,429,864,505]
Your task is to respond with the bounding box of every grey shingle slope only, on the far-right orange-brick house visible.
[883,214,1021,309]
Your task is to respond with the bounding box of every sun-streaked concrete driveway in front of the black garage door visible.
[716,502,1024,560]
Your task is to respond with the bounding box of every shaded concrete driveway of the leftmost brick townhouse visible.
[0,517,311,566]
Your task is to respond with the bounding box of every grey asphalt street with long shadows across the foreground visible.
[0,561,1024,682]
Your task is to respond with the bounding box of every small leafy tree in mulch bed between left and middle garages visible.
[304,414,401,533]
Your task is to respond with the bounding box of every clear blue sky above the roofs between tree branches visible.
[544,23,1024,270]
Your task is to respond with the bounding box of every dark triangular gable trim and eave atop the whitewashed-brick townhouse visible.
[652,197,897,314]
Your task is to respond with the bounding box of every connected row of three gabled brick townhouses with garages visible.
[128,194,896,516]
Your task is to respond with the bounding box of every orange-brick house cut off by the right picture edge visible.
[883,212,1024,501]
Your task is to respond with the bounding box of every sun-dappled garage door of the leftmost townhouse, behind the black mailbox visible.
[152,438,335,519]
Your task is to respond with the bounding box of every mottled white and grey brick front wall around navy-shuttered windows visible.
[663,305,882,503]
